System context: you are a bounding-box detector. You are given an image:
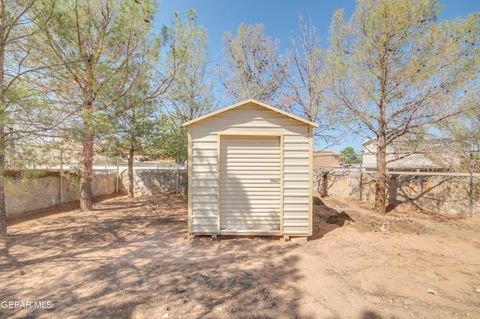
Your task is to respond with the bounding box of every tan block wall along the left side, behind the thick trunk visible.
[5,173,115,215]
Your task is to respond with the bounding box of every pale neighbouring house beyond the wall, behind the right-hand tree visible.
[362,139,460,172]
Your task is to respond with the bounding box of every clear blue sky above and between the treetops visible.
[154,0,480,150]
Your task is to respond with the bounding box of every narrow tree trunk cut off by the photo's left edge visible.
[0,13,7,237]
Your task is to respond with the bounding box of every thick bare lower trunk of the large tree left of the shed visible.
[80,133,94,212]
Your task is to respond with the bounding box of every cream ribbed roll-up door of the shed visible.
[219,136,282,233]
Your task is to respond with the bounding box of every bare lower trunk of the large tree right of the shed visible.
[375,136,387,214]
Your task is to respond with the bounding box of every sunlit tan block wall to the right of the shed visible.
[313,171,480,216]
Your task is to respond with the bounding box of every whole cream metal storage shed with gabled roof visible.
[184,100,317,236]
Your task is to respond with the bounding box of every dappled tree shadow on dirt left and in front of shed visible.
[0,196,314,318]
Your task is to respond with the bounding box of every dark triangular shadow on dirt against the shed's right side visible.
[310,197,354,240]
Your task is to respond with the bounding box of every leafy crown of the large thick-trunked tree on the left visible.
[31,0,159,141]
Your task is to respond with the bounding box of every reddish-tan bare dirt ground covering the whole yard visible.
[0,195,480,319]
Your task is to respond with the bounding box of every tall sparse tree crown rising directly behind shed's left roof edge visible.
[152,10,215,163]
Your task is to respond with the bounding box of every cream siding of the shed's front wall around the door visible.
[190,103,310,235]
